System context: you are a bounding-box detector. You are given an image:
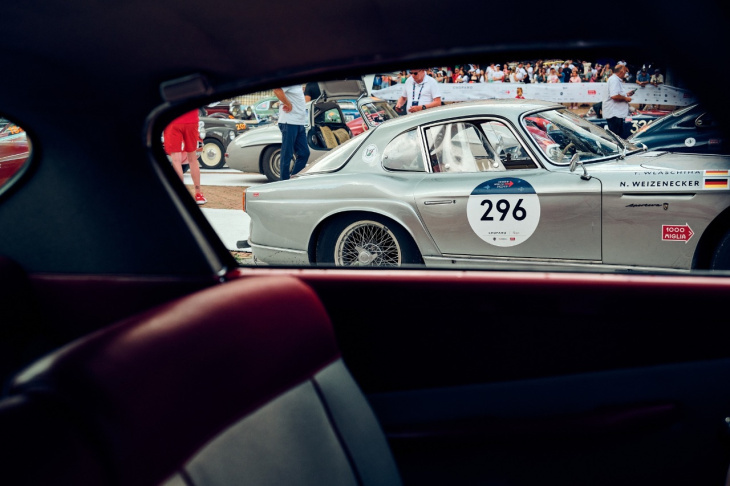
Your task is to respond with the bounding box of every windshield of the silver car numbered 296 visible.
[523,109,639,165]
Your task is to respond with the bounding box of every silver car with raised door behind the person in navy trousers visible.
[226,80,397,181]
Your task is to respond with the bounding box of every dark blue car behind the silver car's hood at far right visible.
[629,104,730,155]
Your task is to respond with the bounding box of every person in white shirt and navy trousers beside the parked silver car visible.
[274,84,309,181]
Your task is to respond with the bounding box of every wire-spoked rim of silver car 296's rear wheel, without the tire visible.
[335,221,402,267]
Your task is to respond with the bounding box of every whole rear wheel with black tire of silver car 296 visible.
[317,214,423,267]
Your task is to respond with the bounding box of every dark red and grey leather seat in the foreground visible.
[0,276,400,486]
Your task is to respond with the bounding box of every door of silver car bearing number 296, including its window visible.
[415,120,601,261]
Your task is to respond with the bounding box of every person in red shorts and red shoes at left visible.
[162,109,203,206]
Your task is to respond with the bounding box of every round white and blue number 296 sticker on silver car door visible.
[466,177,540,246]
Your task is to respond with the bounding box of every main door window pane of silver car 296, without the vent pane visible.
[425,122,494,172]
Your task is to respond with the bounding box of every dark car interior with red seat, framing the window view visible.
[0,0,730,486]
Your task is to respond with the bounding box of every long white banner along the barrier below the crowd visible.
[372,83,697,106]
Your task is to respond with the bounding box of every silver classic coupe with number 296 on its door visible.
[244,100,730,271]
